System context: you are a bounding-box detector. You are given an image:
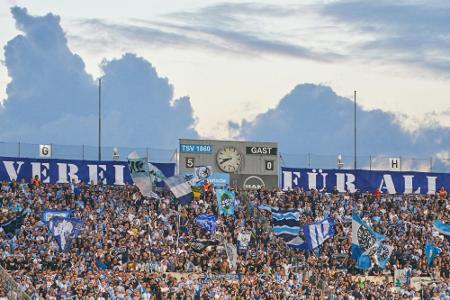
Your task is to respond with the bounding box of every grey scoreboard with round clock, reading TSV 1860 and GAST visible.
[178,139,278,189]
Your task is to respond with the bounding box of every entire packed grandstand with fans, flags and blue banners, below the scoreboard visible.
[0,141,450,299]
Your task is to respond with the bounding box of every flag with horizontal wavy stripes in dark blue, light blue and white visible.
[272,211,301,240]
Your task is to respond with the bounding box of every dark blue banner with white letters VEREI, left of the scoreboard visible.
[0,157,175,186]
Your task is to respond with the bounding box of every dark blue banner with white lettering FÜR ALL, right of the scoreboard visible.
[281,168,450,194]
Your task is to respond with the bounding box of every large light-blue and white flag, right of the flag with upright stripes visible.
[352,211,393,270]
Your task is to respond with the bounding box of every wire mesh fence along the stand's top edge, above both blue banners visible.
[0,142,450,172]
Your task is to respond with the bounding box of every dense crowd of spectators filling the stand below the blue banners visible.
[0,179,450,300]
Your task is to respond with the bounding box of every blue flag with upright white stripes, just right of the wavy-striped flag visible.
[303,218,334,250]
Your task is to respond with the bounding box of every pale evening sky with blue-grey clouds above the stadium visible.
[0,0,450,166]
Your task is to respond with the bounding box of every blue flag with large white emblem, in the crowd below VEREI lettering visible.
[50,217,83,252]
